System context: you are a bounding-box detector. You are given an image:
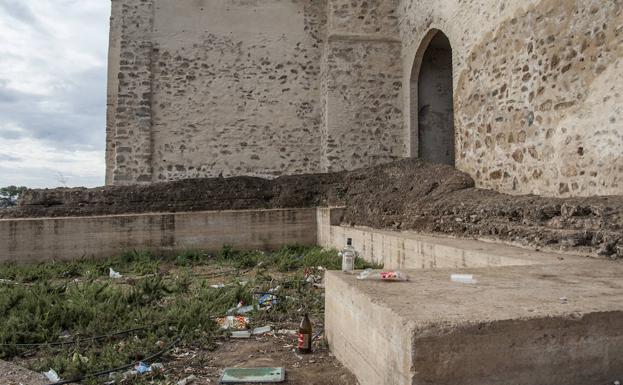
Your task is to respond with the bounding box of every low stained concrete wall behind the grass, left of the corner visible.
[0,209,317,262]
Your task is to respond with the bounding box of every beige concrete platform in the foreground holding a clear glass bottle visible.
[325,260,623,385]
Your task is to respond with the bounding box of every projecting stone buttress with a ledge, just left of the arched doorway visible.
[320,0,405,172]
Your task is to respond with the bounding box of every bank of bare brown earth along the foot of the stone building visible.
[0,159,623,258]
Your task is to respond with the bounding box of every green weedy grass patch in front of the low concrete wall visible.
[0,246,378,384]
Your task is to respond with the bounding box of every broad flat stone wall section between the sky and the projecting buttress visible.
[108,0,326,184]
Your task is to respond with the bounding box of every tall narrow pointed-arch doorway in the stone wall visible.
[411,30,454,166]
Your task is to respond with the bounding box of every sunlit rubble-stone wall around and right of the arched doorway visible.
[398,0,623,196]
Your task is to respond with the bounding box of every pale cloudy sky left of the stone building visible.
[0,0,110,187]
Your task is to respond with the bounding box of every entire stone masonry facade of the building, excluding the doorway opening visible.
[106,0,623,196]
